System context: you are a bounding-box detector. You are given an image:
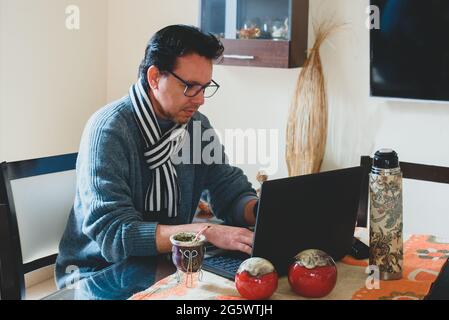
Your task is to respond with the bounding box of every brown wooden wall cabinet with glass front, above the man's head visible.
[200,0,309,68]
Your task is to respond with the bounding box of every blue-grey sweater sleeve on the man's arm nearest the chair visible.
[77,110,157,262]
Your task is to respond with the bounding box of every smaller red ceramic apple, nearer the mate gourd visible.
[235,258,278,300]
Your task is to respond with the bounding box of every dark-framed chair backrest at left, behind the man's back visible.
[0,153,77,299]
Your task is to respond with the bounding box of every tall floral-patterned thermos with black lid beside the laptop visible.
[369,149,403,280]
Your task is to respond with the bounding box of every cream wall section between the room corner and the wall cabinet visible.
[107,0,199,100]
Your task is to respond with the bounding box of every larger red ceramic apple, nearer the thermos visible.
[288,249,337,298]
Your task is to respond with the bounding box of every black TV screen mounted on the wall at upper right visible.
[370,0,449,101]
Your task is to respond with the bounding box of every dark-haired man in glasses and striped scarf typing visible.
[56,25,257,287]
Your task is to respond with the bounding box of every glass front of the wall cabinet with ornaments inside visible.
[201,0,291,40]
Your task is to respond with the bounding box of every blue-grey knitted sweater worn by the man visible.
[56,96,256,287]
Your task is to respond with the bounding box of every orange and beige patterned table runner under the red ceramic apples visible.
[130,235,449,300]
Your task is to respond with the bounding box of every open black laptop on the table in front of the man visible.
[203,167,363,280]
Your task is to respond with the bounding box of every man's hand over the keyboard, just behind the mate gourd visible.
[204,225,254,254]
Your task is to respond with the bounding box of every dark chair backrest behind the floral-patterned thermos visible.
[357,156,449,236]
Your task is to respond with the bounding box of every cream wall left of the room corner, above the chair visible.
[0,0,107,161]
